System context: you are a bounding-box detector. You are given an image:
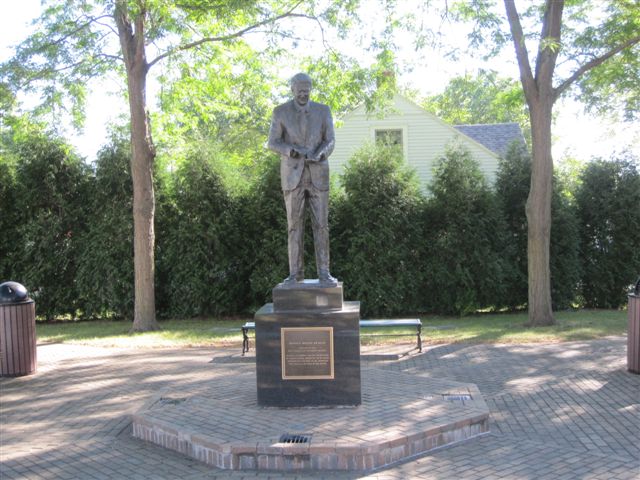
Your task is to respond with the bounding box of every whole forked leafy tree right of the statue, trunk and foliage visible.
[454,0,640,325]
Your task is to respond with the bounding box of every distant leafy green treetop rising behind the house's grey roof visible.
[422,70,529,137]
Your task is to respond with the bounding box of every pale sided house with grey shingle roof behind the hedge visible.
[329,95,524,188]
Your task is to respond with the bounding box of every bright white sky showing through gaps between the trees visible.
[0,0,640,162]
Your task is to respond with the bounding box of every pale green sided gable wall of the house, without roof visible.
[330,95,508,189]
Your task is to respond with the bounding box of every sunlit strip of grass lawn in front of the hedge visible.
[36,310,627,348]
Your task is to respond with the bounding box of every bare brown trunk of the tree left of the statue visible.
[115,0,160,332]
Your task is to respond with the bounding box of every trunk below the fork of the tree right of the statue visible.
[526,99,555,326]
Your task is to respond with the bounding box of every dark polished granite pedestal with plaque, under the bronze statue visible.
[255,280,361,407]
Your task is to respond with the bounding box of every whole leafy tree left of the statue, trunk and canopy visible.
[0,0,364,331]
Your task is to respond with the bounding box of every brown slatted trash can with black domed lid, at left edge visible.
[0,282,37,377]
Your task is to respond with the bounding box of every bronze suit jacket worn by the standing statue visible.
[268,100,335,190]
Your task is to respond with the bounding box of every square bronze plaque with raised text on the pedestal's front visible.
[280,327,334,380]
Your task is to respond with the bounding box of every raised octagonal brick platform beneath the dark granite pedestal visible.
[133,364,489,472]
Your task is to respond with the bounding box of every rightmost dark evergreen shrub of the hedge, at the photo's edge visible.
[576,153,640,308]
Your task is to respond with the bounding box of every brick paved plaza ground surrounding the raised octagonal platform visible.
[0,337,640,480]
